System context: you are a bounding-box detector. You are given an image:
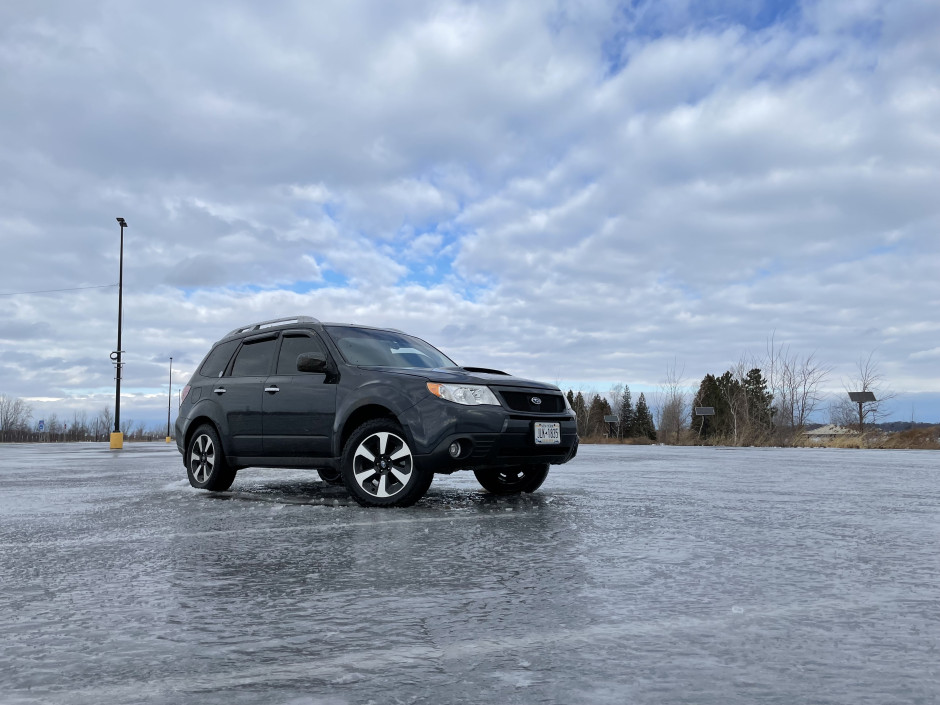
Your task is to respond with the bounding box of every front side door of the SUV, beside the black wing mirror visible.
[262,331,337,457]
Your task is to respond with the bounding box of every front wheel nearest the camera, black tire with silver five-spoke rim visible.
[340,419,434,507]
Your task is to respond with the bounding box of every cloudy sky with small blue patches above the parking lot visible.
[0,0,940,422]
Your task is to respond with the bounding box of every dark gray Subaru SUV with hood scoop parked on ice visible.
[176,316,578,506]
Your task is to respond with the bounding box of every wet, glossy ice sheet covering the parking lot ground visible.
[0,444,940,705]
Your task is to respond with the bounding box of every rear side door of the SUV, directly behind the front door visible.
[218,334,277,456]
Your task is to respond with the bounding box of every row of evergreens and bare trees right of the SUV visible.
[566,337,895,446]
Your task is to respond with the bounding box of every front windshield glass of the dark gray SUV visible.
[326,326,457,368]
